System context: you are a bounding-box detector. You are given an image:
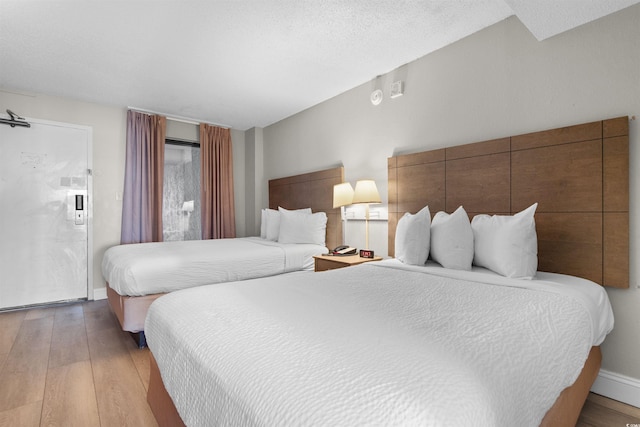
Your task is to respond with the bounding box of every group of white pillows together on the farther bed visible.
[260,207,327,246]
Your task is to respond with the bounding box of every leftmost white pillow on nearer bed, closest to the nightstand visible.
[395,206,431,265]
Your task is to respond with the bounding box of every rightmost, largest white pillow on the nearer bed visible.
[471,203,538,279]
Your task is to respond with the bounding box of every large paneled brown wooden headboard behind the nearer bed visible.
[388,117,629,288]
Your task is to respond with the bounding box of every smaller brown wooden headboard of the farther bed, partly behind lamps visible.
[269,166,344,252]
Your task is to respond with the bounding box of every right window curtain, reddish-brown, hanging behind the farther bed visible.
[200,123,236,239]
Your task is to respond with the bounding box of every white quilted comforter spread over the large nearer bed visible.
[145,262,613,427]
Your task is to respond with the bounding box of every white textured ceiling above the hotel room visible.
[0,0,640,130]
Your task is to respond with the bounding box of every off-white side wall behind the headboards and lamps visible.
[264,5,640,392]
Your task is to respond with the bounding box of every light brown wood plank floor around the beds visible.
[0,300,640,427]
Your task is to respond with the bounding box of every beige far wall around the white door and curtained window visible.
[0,88,245,291]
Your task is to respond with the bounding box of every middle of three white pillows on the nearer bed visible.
[430,206,473,270]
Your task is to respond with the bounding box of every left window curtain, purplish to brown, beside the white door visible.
[120,110,167,244]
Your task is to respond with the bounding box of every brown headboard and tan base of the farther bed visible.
[107,166,344,347]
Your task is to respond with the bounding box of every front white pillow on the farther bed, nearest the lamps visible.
[278,208,327,246]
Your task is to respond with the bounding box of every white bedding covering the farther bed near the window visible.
[102,237,327,296]
